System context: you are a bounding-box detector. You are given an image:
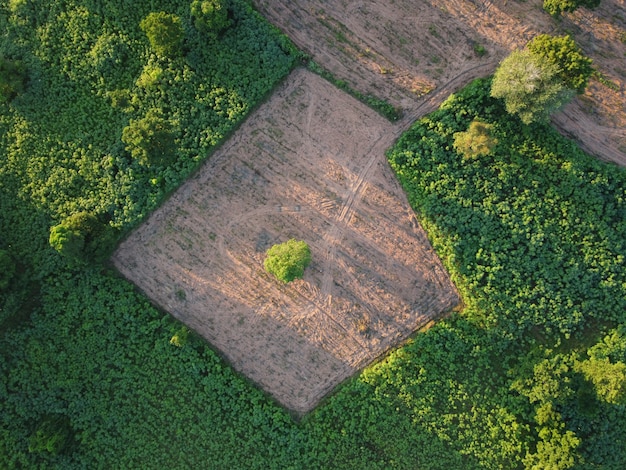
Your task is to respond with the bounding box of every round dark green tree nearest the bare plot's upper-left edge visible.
[122,109,176,166]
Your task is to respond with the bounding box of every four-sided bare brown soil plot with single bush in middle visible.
[113,70,459,412]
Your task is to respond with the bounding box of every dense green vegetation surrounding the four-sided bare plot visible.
[0,0,626,469]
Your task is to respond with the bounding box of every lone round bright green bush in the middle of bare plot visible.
[263,238,311,283]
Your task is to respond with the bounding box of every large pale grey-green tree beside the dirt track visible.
[491,49,574,124]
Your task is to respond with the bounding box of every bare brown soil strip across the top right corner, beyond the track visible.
[254,0,626,165]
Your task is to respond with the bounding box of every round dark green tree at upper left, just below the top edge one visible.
[139,11,184,57]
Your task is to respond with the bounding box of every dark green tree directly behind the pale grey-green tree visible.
[526,34,594,94]
